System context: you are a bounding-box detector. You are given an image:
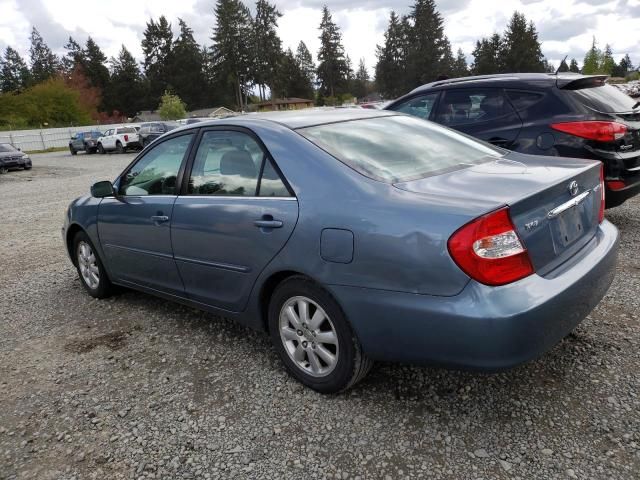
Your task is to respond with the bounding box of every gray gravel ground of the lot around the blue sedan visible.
[0,153,640,480]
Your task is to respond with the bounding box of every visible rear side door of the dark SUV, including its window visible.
[433,88,522,149]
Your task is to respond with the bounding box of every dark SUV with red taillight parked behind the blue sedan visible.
[385,73,640,208]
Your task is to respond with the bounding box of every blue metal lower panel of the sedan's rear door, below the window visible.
[171,196,298,312]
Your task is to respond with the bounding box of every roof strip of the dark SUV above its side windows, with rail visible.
[409,72,606,94]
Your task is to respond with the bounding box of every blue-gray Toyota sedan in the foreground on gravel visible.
[62,109,618,392]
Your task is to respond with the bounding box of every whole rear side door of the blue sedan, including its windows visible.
[171,129,298,312]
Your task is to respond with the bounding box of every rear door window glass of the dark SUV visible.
[435,88,513,126]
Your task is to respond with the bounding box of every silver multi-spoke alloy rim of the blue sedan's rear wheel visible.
[279,296,340,377]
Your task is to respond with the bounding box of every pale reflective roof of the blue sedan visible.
[183,108,397,130]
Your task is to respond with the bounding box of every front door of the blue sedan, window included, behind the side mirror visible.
[98,133,195,295]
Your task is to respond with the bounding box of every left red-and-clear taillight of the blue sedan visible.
[447,207,534,286]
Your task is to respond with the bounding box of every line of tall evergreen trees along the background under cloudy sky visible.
[0,0,634,129]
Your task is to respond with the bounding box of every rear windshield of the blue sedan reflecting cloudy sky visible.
[298,115,504,183]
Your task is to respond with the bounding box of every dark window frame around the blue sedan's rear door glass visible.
[178,123,297,199]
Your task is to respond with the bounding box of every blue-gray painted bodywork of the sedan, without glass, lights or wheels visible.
[64,111,617,368]
